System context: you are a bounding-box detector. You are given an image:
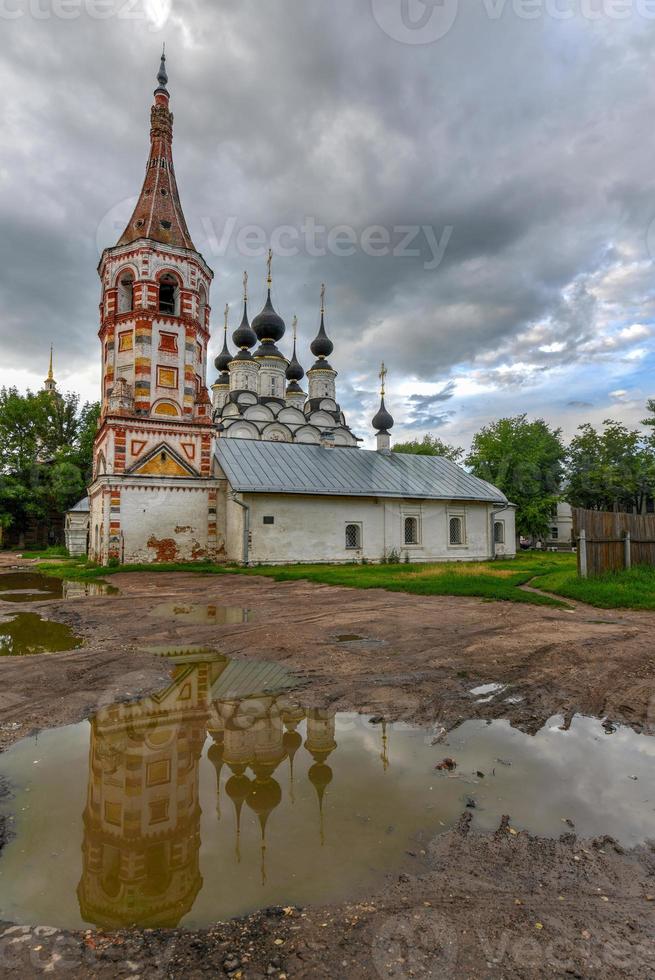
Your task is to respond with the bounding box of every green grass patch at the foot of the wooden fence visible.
[534,565,655,609]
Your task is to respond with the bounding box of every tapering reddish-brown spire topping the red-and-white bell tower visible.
[117,51,195,251]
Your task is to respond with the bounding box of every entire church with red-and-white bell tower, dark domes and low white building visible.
[88,55,516,565]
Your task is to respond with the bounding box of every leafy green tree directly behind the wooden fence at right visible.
[567,419,655,513]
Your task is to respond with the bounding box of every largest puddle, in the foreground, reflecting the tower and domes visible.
[0,649,655,929]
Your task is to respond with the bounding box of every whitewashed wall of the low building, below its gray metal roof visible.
[227,494,514,564]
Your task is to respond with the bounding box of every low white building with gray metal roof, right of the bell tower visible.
[216,439,515,565]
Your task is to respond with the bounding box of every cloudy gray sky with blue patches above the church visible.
[0,0,655,445]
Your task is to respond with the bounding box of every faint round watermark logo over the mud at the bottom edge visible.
[371,908,458,980]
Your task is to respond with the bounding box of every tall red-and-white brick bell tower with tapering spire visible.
[89,54,223,564]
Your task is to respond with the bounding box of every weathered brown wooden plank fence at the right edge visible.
[573,507,655,578]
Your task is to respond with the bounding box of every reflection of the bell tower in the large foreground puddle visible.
[78,664,209,928]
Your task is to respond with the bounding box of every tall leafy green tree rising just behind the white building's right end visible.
[466,415,566,538]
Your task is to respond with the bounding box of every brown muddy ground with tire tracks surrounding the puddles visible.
[0,556,655,980]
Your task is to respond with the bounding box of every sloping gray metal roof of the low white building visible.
[216,438,507,503]
